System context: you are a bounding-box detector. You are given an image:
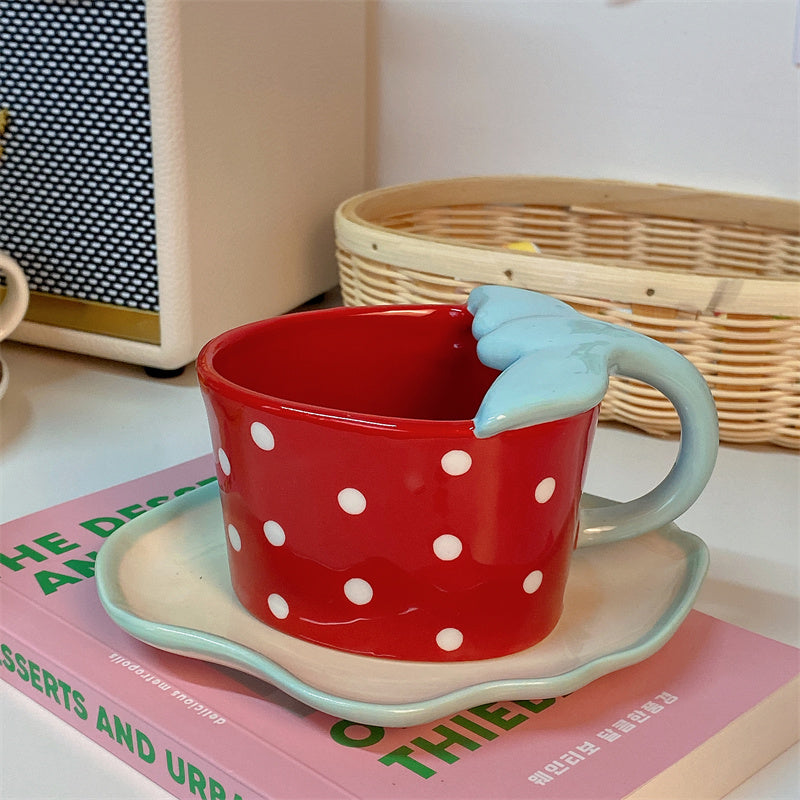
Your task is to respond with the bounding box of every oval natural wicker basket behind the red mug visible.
[335,177,800,448]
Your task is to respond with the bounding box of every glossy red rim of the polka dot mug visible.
[196,303,484,438]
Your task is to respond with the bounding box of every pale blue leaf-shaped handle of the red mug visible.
[467,286,719,546]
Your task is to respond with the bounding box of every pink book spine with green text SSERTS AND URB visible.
[0,615,256,800]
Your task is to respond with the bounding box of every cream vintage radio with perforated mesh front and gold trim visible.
[0,0,366,371]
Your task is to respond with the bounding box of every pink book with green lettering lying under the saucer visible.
[0,456,800,800]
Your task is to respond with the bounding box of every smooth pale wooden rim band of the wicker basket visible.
[334,176,800,318]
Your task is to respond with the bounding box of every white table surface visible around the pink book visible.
[0,304,800,800]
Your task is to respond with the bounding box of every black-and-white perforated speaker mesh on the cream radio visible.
[0,0,158,311]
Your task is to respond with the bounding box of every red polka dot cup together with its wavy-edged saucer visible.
[98,286,718,725]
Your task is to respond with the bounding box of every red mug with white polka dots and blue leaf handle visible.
[197,287,718,661]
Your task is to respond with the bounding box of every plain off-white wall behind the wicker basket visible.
[368,0,800,197]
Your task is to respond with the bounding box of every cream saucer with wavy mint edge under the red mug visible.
[97,484,708,726]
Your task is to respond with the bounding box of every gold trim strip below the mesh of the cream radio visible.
[0,286,161,344]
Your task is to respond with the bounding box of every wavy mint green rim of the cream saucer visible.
[95,484,709,727]
